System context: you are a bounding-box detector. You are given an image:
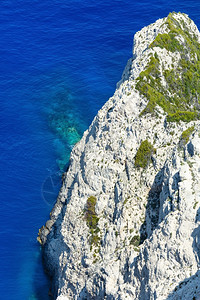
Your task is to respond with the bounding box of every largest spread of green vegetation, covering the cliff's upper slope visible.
[136,13,200,122]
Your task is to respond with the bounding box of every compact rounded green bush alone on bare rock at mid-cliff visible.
[135,140,156,168]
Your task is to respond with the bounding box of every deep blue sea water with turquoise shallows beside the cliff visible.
[0,0,200,300]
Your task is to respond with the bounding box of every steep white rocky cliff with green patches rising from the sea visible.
[38,13,200,300]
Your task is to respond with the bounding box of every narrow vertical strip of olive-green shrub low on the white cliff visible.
[85,196,100,246]
